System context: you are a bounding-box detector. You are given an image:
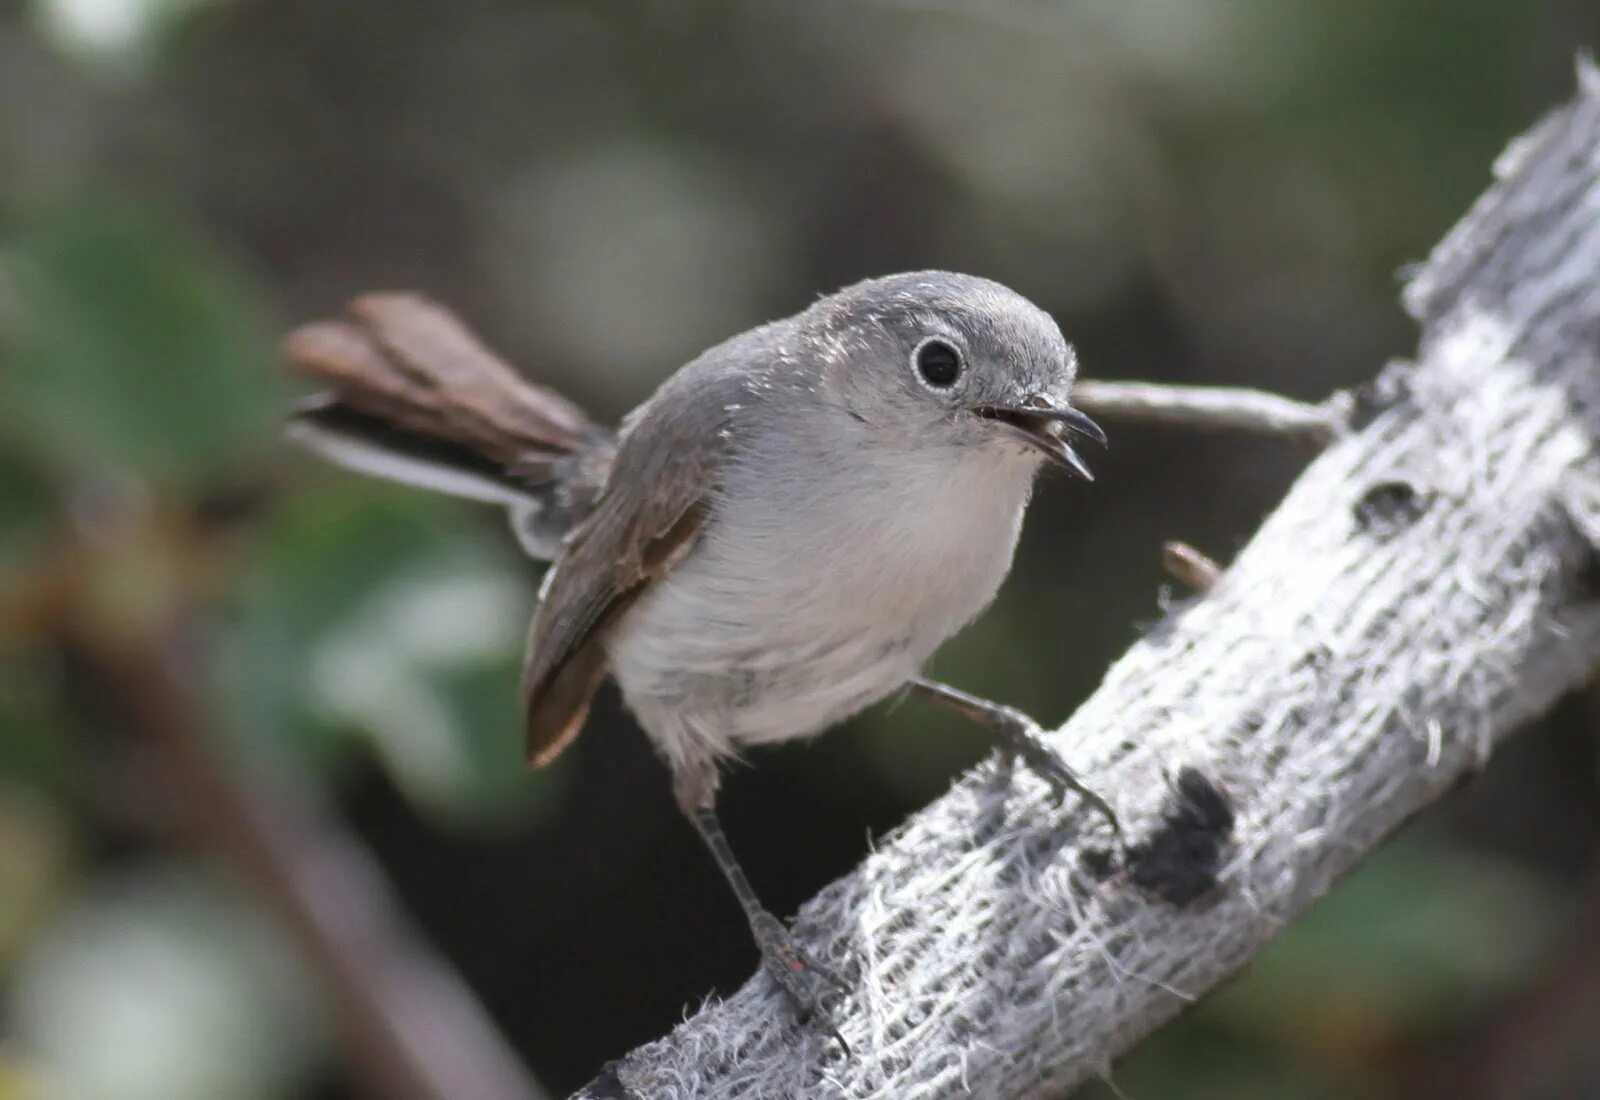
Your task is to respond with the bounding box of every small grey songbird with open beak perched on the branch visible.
[285,272,1115,1034]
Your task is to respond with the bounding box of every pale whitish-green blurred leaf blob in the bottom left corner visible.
[8,865,323,1100]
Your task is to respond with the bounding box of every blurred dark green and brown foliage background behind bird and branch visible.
[0,0,1600,1100]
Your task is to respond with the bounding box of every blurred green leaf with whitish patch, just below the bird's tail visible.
[221,480,550,820]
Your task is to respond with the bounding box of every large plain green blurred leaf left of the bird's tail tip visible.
[0,198,283,488]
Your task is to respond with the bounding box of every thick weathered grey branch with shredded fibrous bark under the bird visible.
[582,69,1600,1100]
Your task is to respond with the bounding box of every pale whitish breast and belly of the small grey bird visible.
[610,428,1035,773]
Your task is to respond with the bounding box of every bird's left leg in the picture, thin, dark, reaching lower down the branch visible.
[675,764,850,1054]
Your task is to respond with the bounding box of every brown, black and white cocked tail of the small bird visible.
[283,294,616,560]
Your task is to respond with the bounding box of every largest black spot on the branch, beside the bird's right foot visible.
[1128,767,1234,905]
